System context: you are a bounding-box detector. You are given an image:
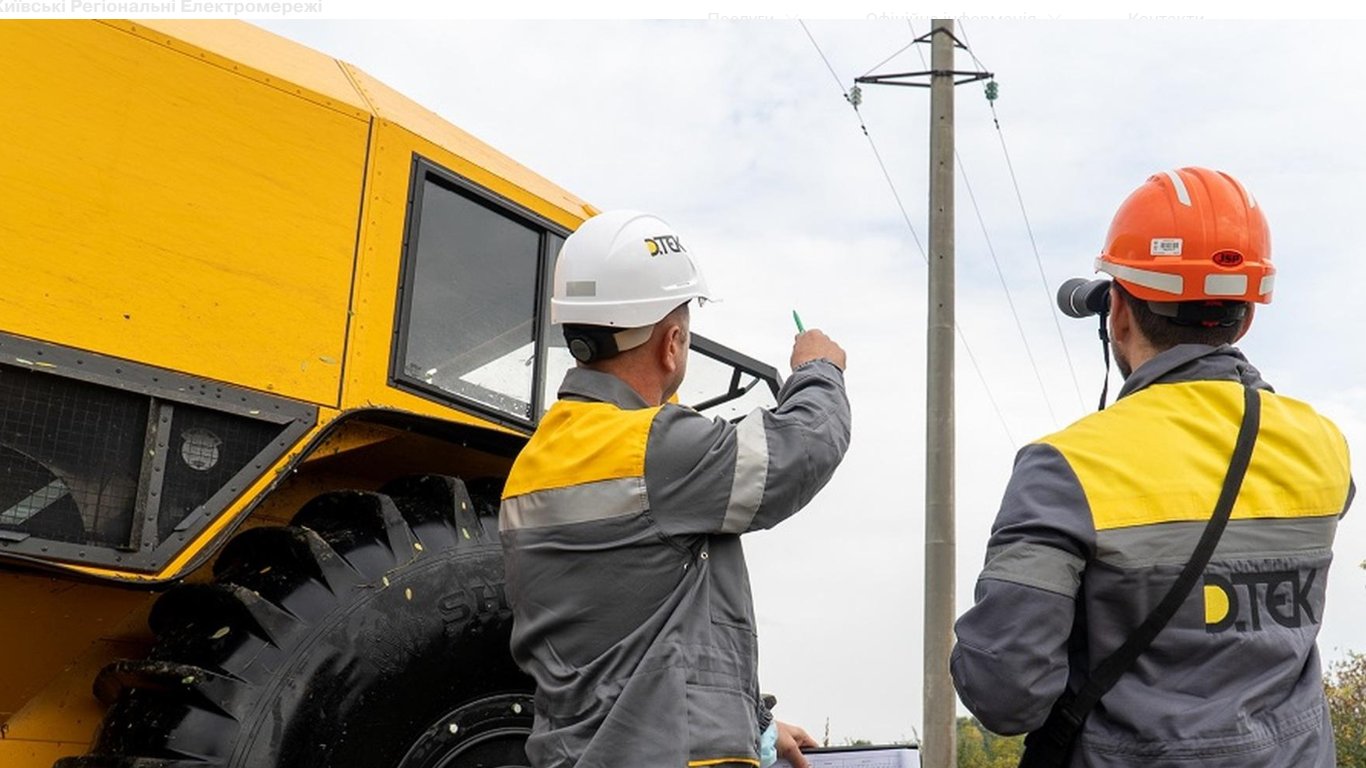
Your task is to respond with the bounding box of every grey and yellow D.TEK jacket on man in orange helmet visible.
[951,344,1352,768]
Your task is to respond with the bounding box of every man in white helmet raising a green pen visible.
[499,210,850,768]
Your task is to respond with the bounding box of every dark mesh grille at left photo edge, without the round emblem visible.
[0,365,148,547]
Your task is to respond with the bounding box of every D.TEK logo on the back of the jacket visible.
[1205,568,1318,634]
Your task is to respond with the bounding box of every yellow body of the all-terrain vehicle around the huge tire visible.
[0,20,609,768]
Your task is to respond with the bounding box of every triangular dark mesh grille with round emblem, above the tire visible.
[157,404,287,540]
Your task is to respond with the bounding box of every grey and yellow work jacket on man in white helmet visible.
[499,361,850,768]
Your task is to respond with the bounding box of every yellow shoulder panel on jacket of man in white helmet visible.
[503,400,660,497]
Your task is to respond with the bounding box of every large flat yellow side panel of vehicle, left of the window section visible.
[0,22,369,404]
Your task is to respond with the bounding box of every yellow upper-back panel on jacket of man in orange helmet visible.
[1041,381,1351,530]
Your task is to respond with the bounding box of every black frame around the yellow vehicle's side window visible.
[388,152,571,433]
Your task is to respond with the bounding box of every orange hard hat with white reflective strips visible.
[1096,168,1276,303]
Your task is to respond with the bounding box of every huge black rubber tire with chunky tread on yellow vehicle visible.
[56,476,531,768]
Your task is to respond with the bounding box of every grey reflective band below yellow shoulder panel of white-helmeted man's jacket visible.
[499,477,649,530]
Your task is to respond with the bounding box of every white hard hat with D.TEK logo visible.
[550,210,710,328]
